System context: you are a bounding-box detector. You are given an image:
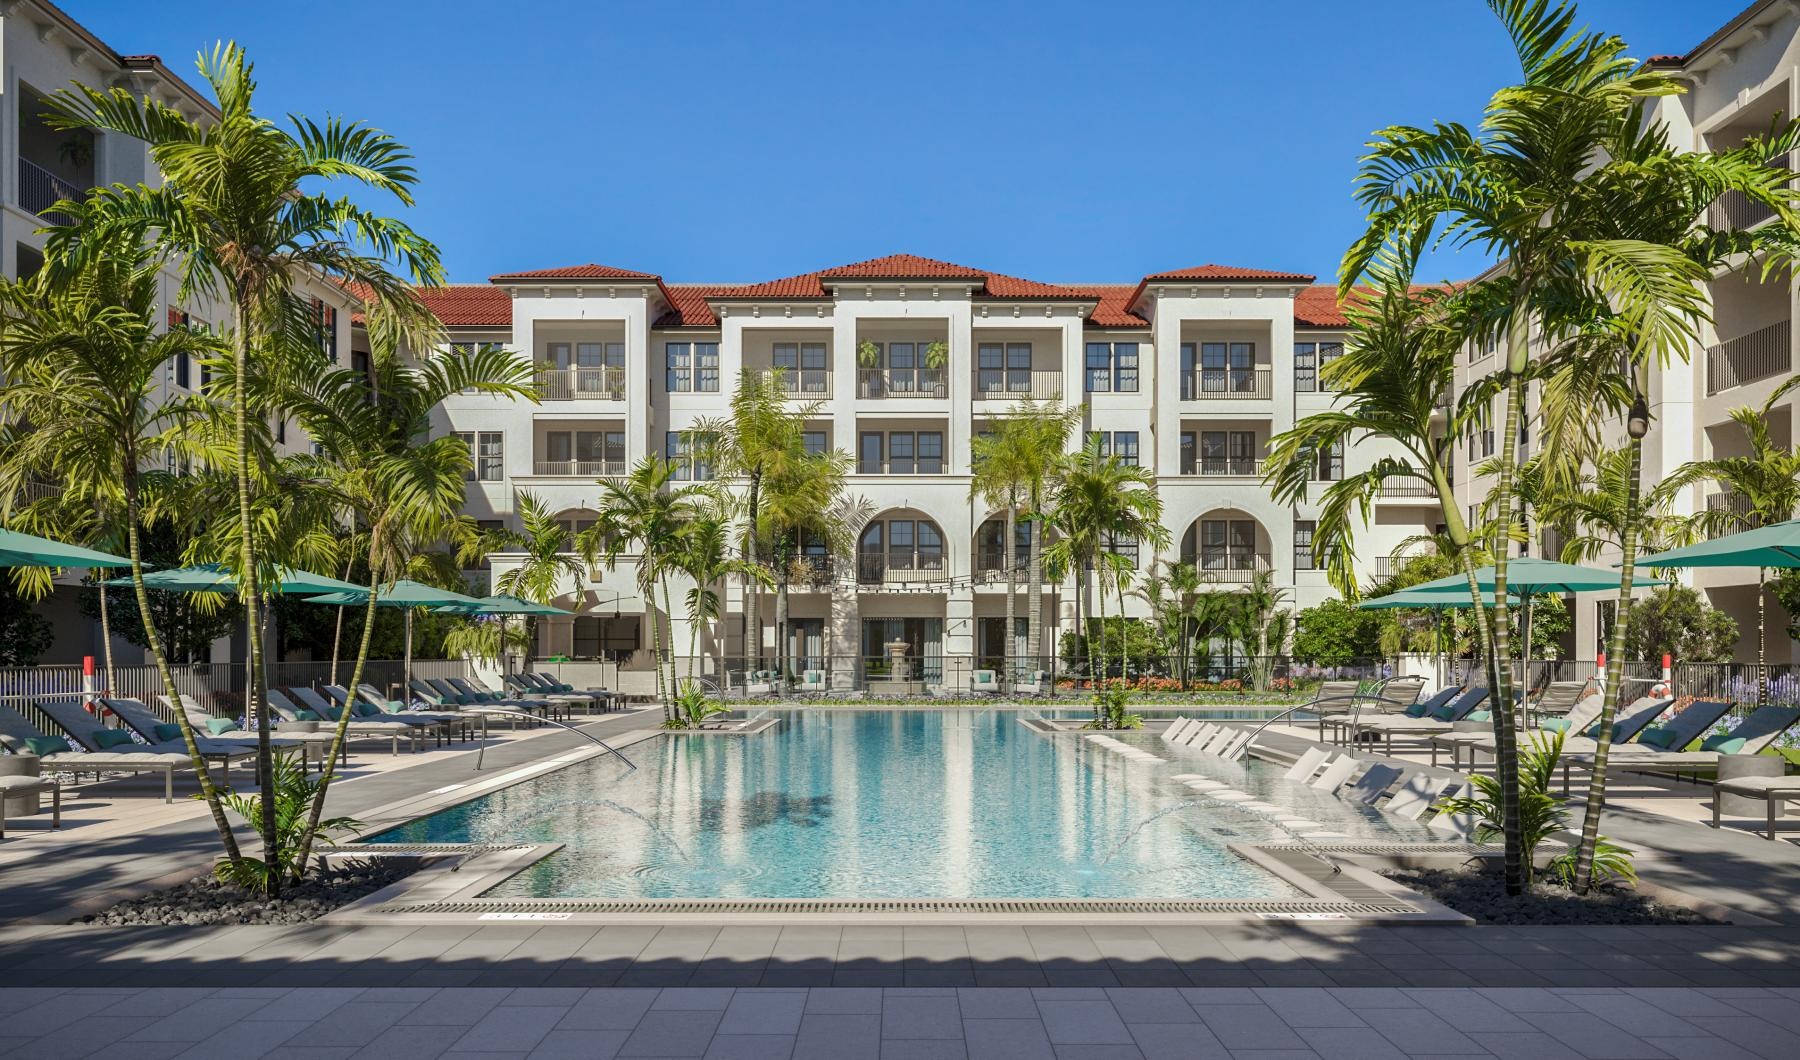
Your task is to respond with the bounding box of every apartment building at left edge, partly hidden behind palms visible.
[0,0,356,664]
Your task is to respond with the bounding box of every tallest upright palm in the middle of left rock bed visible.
[47,43,443,889]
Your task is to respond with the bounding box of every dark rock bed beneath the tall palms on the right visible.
[1381,864,1721,925]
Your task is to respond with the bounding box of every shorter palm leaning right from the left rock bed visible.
[290,304,536,866]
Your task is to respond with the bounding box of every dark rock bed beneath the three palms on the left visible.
[70,858,419,925]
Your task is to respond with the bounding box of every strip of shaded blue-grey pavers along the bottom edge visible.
[0,986,1800,1060]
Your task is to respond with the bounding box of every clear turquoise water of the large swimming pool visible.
[369,709,1422,898]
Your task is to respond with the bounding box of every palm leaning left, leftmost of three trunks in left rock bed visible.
[0,235,241,866]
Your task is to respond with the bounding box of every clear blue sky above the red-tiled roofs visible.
[77,0,1746,283]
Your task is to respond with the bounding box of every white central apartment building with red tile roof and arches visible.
[417,254,1436,673]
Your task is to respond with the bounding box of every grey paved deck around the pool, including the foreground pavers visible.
[10,705,1800,1060]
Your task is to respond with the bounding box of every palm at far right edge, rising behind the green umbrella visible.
[1661,394,1800,707]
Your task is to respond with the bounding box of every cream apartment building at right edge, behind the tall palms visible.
[1456,0,1800,662]
